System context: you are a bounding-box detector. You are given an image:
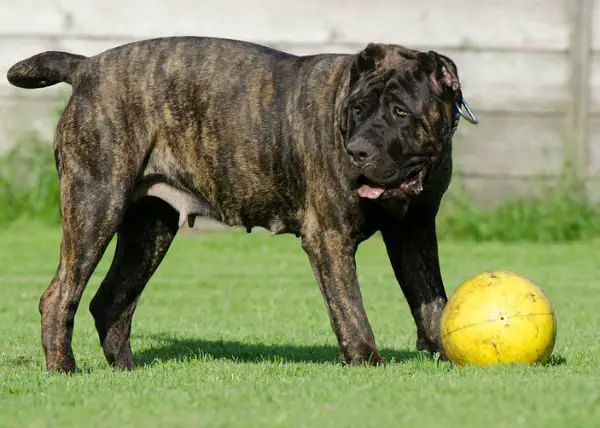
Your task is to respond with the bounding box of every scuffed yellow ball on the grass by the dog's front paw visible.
[442,271,556,366]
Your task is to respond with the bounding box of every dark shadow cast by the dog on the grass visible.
[134,336,431,366]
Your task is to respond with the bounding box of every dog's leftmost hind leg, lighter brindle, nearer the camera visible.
[39,166,133,372]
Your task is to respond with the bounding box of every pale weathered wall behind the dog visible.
[0,0,600,203]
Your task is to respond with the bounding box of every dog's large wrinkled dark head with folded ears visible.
[340,43,474,199]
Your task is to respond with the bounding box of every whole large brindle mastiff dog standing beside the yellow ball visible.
[8,37,478,372]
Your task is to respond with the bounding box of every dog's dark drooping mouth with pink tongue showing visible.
[357,163,430,199]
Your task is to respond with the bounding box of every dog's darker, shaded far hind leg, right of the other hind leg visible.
[90,197,179,369]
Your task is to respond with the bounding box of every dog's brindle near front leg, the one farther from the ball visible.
[302,230,383,365]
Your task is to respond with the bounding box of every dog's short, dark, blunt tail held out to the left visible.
[6,51,86,89]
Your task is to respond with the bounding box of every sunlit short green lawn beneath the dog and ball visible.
[0,225,600,428]
